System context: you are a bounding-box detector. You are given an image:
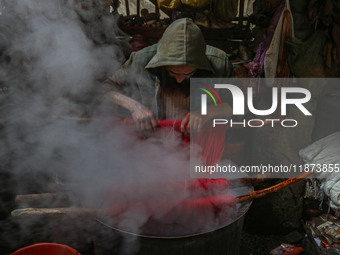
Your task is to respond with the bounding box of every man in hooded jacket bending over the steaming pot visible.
[105,18,234,133]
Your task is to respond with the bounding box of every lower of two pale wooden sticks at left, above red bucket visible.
[11,207,109,218]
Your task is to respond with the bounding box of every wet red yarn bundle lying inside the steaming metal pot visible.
[106,179,236,234]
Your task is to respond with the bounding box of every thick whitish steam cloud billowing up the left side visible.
[3,0,191,201]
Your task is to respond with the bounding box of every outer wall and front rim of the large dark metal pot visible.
[95,185,252,255]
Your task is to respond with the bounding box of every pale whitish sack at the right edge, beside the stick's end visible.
[299,132,340,209]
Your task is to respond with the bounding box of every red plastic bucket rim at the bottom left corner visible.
[11,243,80,255]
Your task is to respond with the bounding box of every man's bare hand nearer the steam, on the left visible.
[131,102,158,134]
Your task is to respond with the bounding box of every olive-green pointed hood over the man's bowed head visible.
[145,18,213,72]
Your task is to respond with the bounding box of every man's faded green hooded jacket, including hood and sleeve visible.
[106,18,234,118]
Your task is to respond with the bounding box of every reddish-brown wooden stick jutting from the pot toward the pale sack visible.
[236,171,313,203]
